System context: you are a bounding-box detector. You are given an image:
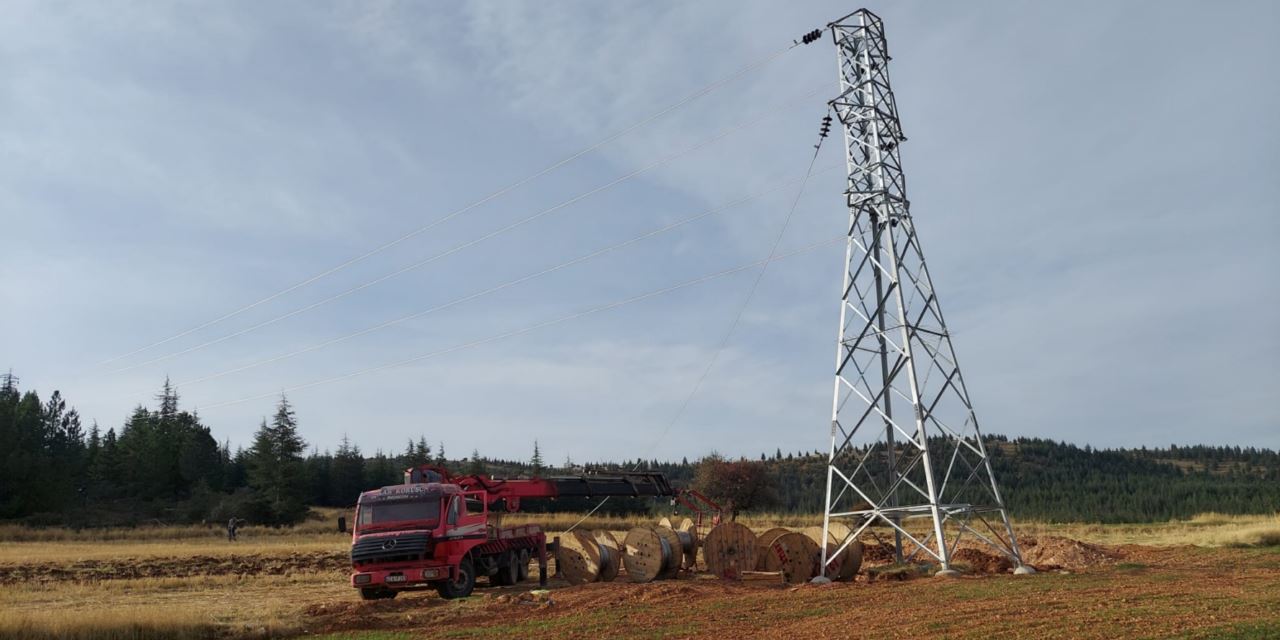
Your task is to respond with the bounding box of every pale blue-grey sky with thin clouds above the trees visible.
[0,0,1280,462]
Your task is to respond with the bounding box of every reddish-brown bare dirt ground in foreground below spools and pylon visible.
[296,539,1280,639]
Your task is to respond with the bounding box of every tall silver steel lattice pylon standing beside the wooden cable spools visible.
[823,9,1021,568]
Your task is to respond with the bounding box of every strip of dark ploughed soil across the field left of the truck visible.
[0,552,351,584]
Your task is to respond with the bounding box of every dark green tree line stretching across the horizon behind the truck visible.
[0,375,1280,526]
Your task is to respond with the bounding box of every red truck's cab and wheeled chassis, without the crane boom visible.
[351,481,545,599]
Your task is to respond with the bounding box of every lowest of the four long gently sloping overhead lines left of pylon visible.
[200,236,846,411]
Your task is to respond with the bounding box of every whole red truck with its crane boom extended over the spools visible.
[351,466,677,600]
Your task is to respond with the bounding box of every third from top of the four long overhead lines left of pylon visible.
[177,165,844,388]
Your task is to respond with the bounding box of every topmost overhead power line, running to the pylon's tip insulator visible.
[97,45,795,366]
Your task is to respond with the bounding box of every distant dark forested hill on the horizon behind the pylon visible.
[488,435,1280,522]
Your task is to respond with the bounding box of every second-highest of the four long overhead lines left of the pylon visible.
[110,90,822,374]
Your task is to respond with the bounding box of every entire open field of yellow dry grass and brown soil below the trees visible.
[0,512,1280,640]
